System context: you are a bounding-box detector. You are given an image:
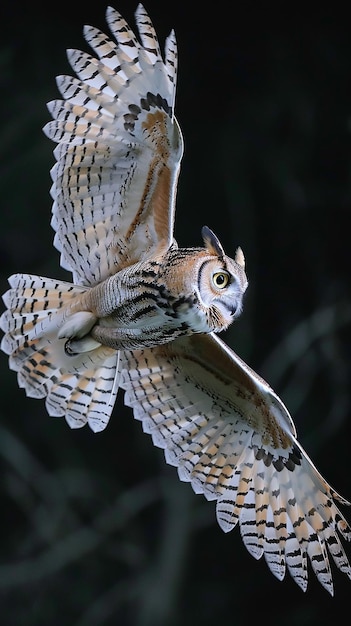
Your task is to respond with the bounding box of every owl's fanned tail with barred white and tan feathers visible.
[0,274,119,432]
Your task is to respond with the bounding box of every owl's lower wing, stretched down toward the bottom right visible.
[122,335,351,594]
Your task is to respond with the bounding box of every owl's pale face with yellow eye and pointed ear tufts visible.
[198,226,248,332]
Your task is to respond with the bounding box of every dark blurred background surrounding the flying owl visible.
[0,0,351,626]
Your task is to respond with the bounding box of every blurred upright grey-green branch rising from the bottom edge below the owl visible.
[75,468,194,626]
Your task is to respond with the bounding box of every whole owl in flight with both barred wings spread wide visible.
[0,5,351,594]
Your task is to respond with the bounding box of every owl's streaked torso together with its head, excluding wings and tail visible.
[50,228,248,356]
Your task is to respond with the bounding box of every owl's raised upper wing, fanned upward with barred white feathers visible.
[44,5,183,285]
